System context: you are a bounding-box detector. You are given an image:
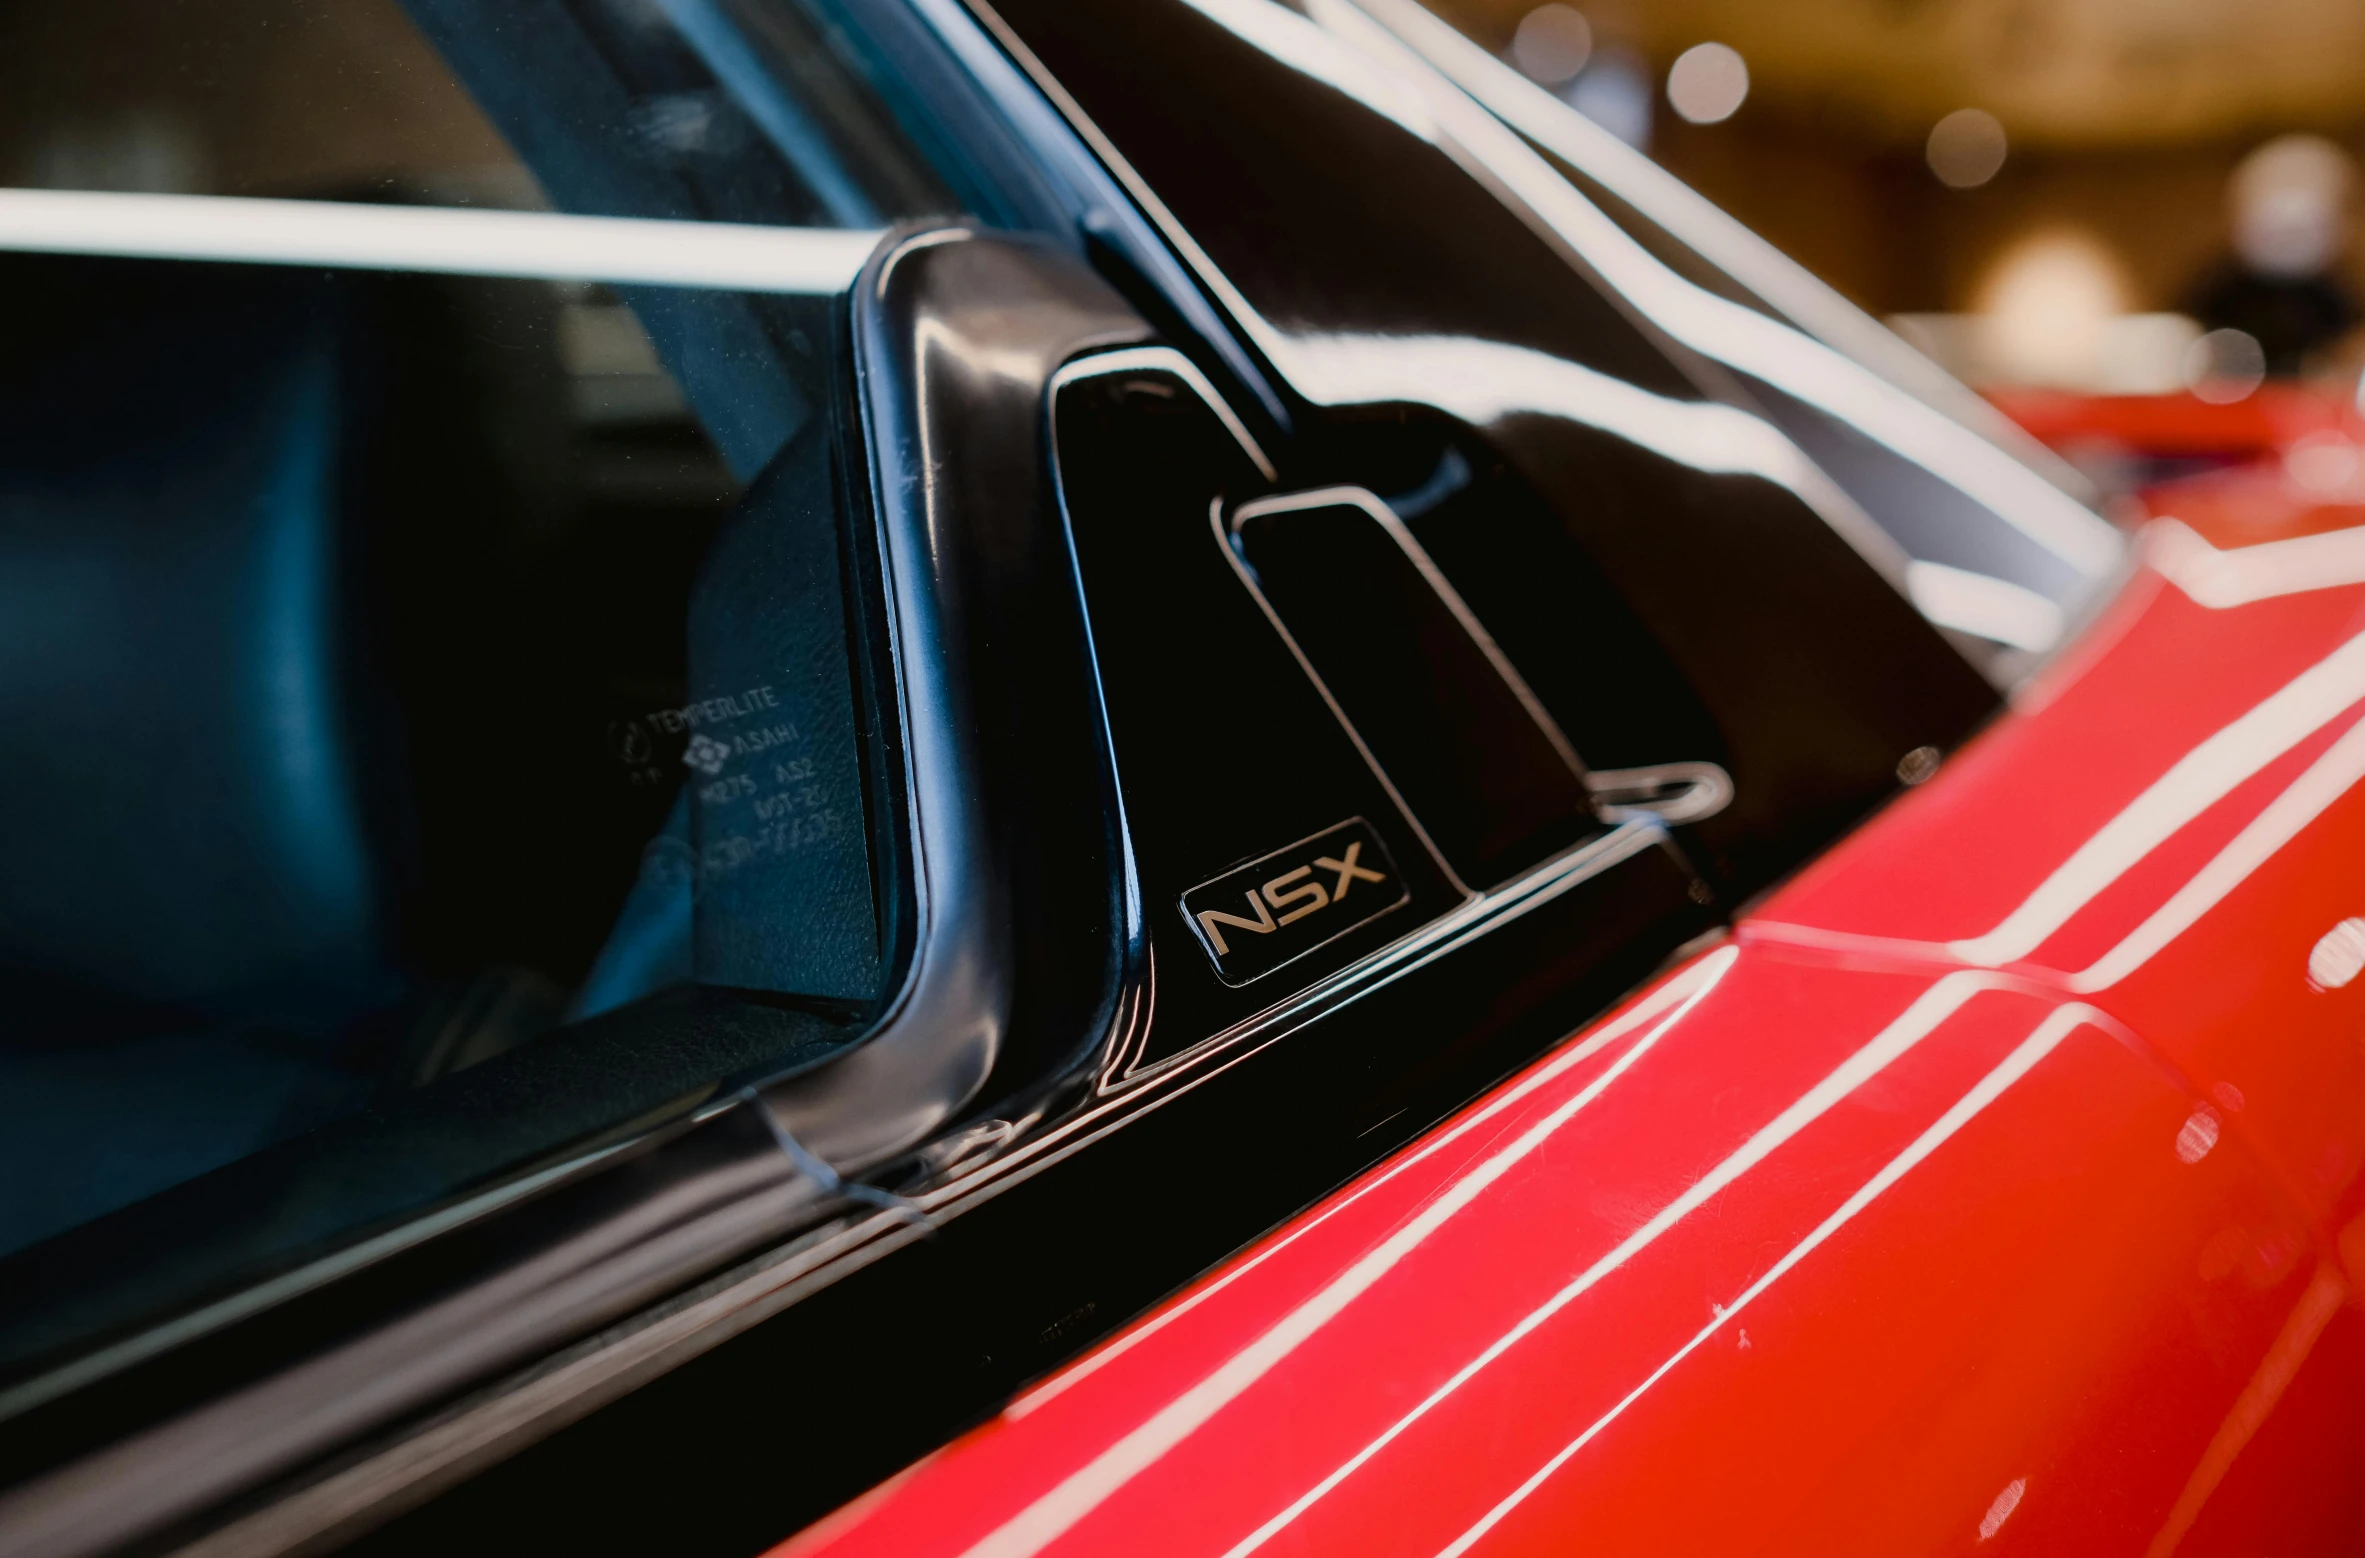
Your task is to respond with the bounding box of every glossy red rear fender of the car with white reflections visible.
[785,522,2365,1558]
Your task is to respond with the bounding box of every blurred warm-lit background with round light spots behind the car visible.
[1436,0,2365,492]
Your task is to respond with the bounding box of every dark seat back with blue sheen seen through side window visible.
[0,258,381,1030]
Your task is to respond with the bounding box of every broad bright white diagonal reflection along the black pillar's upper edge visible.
[1308,0,2121,579]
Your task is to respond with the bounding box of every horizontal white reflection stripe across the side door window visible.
[0,189,880,296]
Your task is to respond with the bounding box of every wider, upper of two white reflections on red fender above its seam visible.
[1949,634,2365,967]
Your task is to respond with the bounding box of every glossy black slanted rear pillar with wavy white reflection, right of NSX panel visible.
[996,0,2014,901]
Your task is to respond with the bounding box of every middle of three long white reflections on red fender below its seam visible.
[1225,969,2006,1558]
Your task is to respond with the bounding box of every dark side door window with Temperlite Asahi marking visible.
[0,0,970,1361]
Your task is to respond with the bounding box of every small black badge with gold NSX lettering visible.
[1183,818,1412,984]
